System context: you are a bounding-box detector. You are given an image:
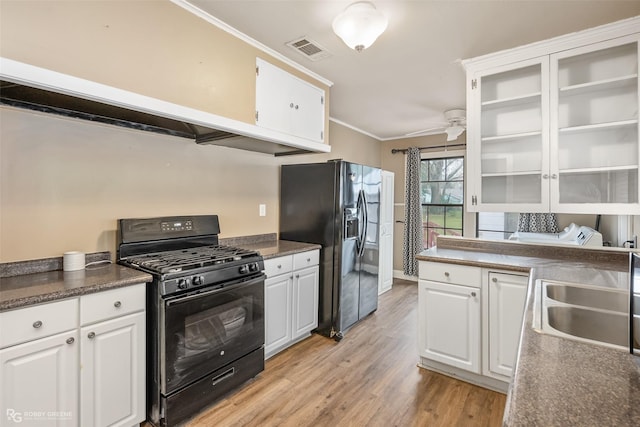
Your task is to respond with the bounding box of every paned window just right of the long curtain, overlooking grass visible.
[420,156,464,248]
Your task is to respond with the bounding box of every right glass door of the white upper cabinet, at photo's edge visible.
[550,34,640,214]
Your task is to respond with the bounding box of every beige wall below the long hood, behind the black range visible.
[0,107,380,262]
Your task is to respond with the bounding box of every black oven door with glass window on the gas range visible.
[160,274,265,395]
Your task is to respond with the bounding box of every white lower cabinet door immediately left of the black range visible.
[80,312,146,427]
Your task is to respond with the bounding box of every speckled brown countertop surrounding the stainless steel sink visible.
[417,238,640,426]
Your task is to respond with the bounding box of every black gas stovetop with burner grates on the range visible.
[123,245,262,274]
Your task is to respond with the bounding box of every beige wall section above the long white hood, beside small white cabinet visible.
[0,0,329,142]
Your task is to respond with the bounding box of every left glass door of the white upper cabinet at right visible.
[467,56,549,212]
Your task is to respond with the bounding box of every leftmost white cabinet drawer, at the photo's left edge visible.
[0,298,78,348]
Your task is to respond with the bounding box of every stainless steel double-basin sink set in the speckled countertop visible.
[533,280,629,350]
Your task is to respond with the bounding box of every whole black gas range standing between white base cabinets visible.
[117,215,265,426]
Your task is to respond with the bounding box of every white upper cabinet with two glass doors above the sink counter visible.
[464,18,640,214]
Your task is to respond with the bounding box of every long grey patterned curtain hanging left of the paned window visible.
[402,147,424,276]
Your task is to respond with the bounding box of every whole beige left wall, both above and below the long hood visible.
[0,0,381,262]
